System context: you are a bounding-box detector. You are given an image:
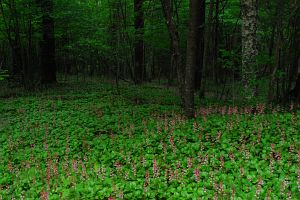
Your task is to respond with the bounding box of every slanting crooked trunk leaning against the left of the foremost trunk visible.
[161,0,185,101]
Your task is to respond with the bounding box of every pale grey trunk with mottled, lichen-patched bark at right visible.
[241,0,258,99]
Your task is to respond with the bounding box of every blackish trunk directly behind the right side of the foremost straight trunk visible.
[195,0,205,90]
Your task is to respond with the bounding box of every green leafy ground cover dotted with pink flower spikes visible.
[0,84,300,199]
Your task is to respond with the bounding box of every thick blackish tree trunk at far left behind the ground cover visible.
[40,0,56,85]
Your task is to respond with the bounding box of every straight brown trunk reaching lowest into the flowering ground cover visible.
[185,0,201,118]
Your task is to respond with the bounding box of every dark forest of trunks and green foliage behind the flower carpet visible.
[0,0,300,116]
